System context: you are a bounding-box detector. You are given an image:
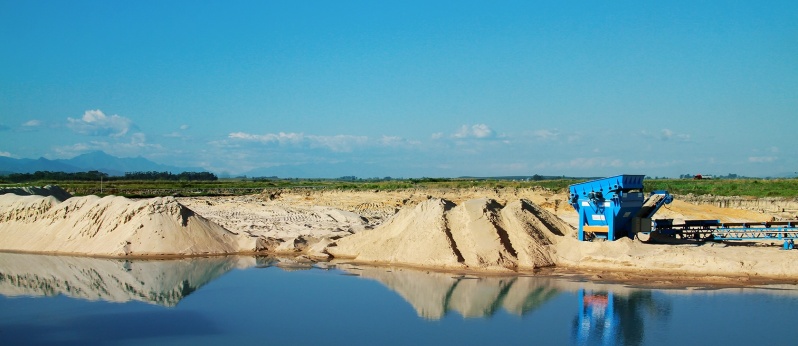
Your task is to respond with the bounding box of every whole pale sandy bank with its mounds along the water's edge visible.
[0,188,798,283]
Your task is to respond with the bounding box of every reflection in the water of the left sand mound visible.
[0,253,238,306]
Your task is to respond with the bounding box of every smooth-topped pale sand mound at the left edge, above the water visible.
[0,194,255,256]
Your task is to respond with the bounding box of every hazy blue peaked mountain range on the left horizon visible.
[0,151,206,176]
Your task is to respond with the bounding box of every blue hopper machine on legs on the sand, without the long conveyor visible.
[569,174,673,240]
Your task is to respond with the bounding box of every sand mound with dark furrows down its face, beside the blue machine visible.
[327,198,573,270]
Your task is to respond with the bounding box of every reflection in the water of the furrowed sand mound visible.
[343,267,559,319]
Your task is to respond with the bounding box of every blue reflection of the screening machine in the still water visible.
[576,289,621,345]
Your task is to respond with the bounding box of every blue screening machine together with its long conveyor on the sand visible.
[569,174,798,249]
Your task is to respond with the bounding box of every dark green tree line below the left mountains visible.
[2,171,219,183]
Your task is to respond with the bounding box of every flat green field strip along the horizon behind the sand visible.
[6,179,798,198]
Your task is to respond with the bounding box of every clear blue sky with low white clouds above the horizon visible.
[0,0,798,177]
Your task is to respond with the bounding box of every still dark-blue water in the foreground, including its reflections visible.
[0,253,798,345]
